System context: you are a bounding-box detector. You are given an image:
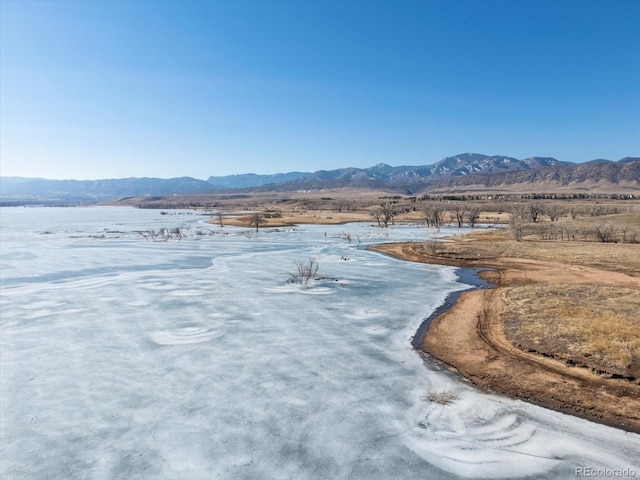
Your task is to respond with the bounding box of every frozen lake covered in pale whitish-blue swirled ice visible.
[0,207,640,480]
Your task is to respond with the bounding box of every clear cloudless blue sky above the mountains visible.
[0,0,640,179]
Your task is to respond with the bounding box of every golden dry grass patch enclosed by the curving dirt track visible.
[502,284,640,378]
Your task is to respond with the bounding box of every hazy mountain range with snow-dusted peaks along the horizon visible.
[0,153,640,202]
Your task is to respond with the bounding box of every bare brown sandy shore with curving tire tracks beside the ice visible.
[373,243,640,433]
